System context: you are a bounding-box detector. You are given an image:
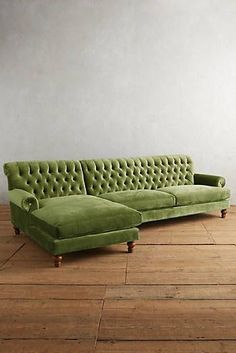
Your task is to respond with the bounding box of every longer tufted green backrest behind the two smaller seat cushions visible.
[81,155,193,196]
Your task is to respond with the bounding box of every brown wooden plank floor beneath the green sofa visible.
[0,205,236,353]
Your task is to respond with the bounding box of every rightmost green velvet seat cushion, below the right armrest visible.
[160,185,230,206]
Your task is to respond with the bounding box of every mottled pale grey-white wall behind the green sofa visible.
[0,0,236,203]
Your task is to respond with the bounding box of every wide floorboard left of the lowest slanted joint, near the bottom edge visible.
[0,299,102,339]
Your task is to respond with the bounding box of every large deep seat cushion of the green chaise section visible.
[31,195,141,239]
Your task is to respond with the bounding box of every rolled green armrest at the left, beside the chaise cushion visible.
[8,189,39,212]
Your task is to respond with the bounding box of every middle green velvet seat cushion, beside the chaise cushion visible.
[99,190,175,211]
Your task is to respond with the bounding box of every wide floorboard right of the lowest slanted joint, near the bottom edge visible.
[99,299,236,341]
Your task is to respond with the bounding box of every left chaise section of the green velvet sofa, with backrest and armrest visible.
[4,161,141,267]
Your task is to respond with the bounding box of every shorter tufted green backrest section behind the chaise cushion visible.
[4,161,86,199]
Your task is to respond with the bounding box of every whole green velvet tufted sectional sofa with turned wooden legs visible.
[4,155,230,267]
